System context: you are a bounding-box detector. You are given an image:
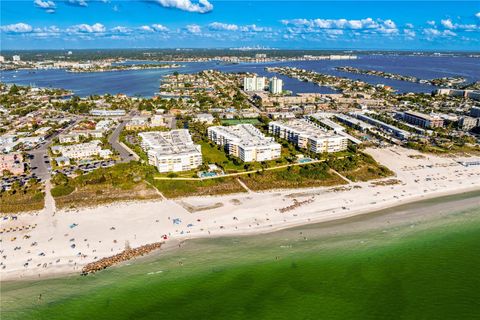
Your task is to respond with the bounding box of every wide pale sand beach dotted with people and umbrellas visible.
[0,147,480,281]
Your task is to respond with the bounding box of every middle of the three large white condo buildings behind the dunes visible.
[208,124,281,162]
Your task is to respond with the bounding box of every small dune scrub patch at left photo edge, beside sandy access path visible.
[0,179,45,213]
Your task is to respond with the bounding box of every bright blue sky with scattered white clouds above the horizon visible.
[0,0,480,51]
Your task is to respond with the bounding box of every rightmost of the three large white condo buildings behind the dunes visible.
[268,119,348,153]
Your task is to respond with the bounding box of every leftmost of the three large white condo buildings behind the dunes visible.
[139,129,202,172]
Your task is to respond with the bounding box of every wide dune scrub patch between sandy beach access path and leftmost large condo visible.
[51,162,159,208]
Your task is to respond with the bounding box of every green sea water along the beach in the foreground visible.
[1,196,480,320]
